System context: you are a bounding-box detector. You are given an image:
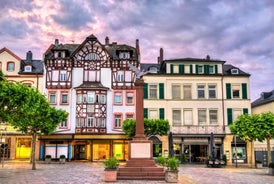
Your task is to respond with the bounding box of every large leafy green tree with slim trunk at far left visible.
[0,81,68,170]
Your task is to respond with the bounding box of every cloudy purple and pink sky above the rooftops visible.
[0,0,274,102]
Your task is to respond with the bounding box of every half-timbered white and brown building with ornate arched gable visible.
[39,35,140,161]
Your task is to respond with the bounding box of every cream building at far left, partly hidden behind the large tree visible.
[0,47,43,159]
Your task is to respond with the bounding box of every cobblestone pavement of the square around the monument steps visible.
[0,161,274,184]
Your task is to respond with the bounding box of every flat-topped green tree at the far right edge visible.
[230,112,274,163]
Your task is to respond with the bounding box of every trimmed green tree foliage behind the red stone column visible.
[122,118,170,138]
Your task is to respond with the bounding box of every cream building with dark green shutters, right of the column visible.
[141,49,252,165]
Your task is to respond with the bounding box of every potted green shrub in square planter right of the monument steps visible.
[165,157,179,183]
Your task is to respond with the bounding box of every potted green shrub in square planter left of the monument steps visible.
[103,157,119,181]
